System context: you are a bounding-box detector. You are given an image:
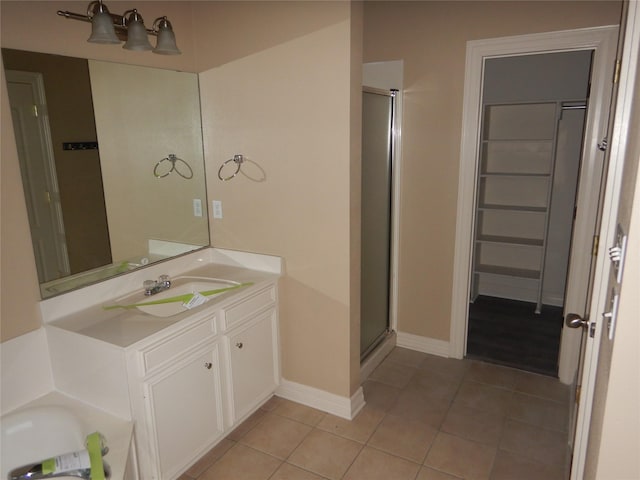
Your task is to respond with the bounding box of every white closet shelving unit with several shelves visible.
[471,102,561,313]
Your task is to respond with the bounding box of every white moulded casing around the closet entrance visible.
[449,26,618,384]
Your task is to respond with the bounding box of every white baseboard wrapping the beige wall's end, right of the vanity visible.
[276,379,364,420]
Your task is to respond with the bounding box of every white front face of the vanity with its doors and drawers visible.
[127,283,280,480]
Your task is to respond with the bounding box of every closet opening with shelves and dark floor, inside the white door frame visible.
[467,50,593,377]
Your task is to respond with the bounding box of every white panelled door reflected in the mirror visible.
[6,70,70,283]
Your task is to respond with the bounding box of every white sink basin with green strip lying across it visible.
[107,277,241,317]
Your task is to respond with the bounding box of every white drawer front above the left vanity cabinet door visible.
[141,315,217,375]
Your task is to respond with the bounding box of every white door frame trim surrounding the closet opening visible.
[449,25,618,384]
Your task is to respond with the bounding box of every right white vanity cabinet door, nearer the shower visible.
[227,309,279,422]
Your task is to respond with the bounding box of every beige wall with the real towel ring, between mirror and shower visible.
[196,2,362,396]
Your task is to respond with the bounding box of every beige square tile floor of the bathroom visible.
[179,348,569,480]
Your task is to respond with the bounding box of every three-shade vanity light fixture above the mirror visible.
[58,0,182,55]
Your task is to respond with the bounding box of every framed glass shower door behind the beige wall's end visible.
[360,89,394,359]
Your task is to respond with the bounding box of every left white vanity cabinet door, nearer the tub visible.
[145,345,224,479]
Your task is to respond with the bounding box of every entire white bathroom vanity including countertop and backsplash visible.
[41,248,282,480]
